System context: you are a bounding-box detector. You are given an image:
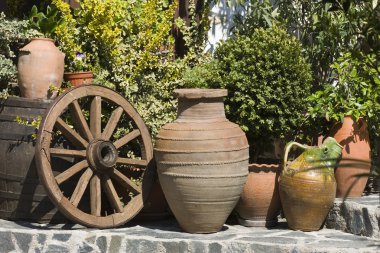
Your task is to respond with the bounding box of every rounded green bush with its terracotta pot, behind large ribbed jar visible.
[184,26,311,226]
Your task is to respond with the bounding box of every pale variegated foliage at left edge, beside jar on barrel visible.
[0,13,38,94]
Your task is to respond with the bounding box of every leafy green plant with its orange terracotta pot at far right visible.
[309,52,380,197]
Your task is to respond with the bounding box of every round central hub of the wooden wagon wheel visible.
[86,140,118,173]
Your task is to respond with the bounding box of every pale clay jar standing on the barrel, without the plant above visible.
[17,38,65,99]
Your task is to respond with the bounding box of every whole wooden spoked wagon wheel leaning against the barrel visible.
[36,85,155,228]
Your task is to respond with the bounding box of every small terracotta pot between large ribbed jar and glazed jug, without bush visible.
[235,164,281,227]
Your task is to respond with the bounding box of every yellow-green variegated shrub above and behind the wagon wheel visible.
[46,0,208,136]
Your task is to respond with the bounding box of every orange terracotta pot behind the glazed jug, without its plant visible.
[331,116,371,198]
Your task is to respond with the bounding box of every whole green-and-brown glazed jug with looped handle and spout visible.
[279,137,342,231]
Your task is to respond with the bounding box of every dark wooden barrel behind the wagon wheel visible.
[0,97,66,223]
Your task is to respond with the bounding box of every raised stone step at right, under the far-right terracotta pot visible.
[325,195,380,239]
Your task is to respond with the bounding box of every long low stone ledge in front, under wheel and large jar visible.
[0,219,380,253]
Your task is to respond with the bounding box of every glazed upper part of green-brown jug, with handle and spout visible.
[282,137,343,181]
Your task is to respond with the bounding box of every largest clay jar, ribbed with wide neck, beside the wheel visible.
[155,89,248,233]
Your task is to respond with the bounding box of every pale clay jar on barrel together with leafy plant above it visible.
[17,6,65,99]
